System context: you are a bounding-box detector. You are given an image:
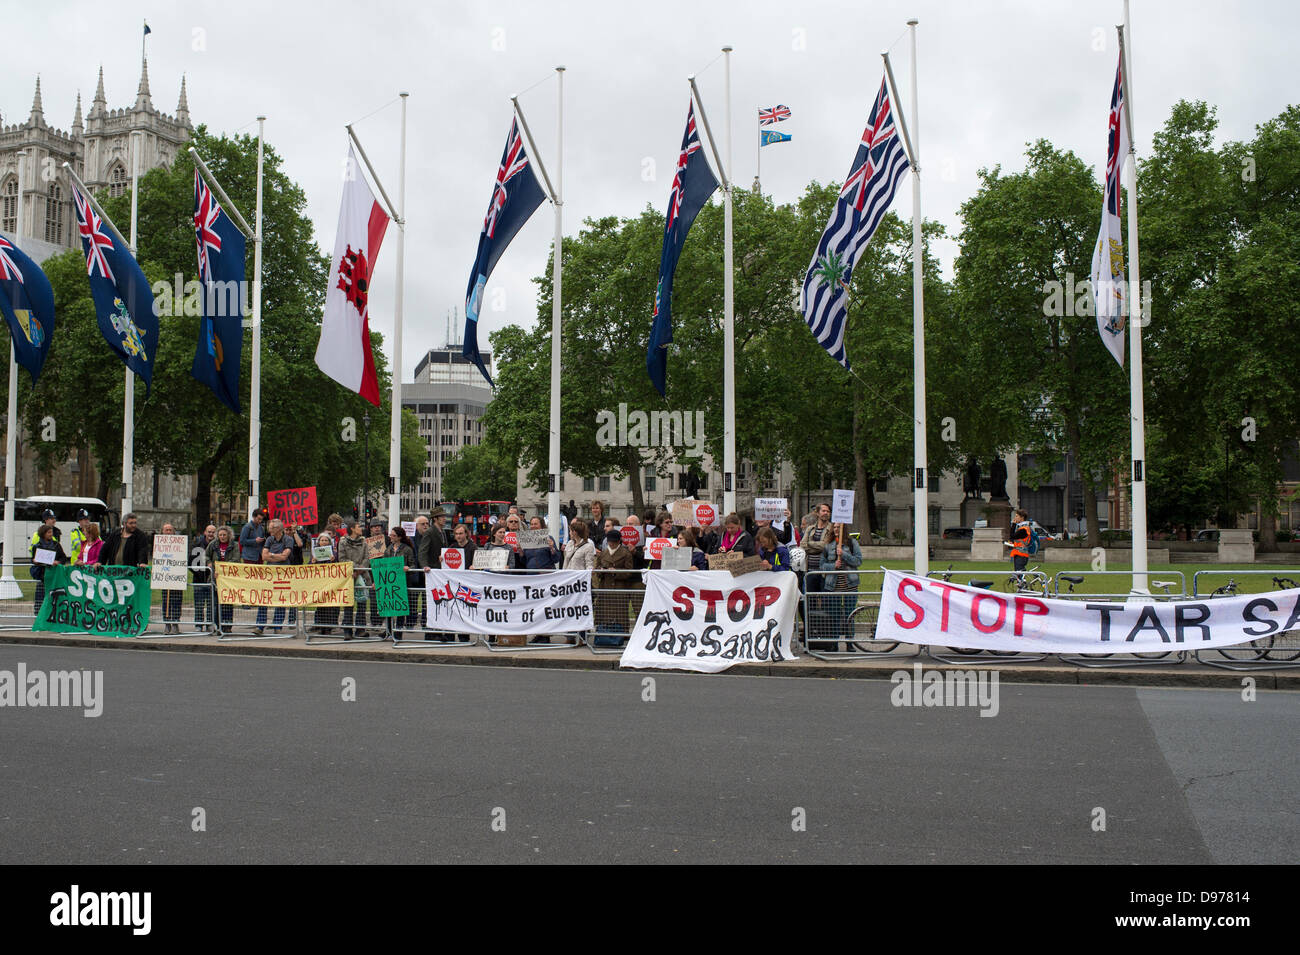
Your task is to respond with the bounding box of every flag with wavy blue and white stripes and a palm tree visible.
[800,79,907,368]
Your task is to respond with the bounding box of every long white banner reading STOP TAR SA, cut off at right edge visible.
[876,570,1300,654]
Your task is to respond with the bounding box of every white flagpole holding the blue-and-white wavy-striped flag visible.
[907,19,930,577]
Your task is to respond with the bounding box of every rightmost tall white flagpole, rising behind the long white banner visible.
[1119,0,1149,592]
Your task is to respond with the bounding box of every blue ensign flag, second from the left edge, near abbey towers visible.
[73,183,159,395]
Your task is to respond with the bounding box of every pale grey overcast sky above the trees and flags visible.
[0,0,1300,381]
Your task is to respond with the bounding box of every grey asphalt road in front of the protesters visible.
[0,646,1300,864]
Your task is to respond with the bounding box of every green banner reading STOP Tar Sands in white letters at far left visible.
[31,564,151,637]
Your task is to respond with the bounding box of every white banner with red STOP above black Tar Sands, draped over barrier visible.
[621,570,800,673]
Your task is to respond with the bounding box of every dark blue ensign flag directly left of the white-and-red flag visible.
[190,169,244,414]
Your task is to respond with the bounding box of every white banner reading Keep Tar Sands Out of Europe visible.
[425,566,592,634]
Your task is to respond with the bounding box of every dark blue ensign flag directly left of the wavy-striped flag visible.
[646,103,718,395]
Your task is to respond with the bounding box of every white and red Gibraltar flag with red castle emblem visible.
[316,147,389,408]
